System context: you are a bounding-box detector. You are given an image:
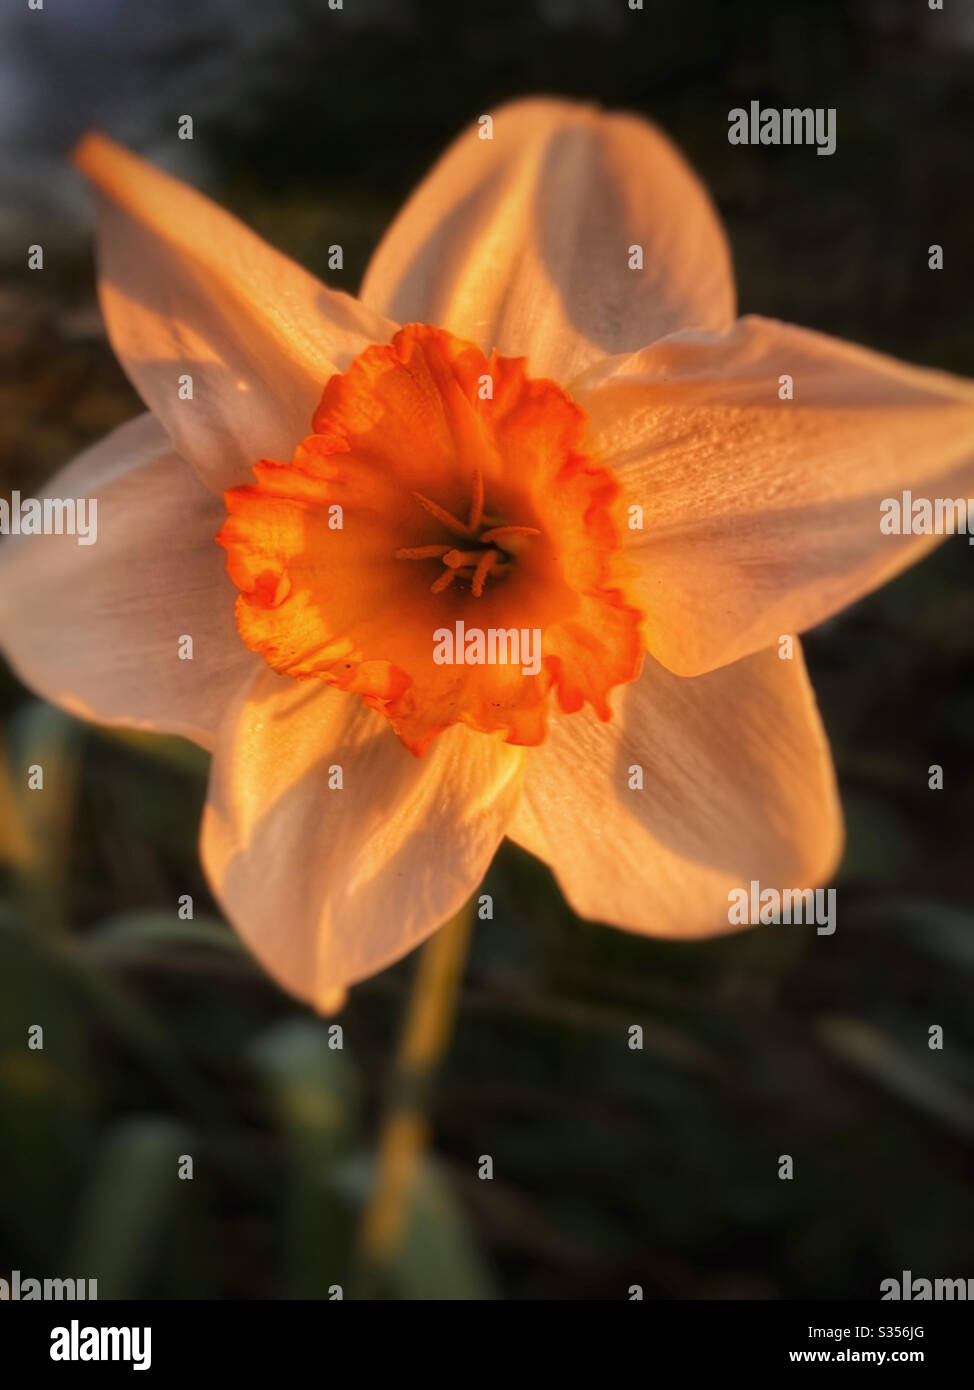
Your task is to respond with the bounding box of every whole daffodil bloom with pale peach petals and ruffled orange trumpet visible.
[1,100,974,1006]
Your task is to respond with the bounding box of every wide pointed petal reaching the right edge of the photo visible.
[572,317,974,676]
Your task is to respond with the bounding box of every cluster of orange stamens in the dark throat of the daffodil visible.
[395,468,540,599]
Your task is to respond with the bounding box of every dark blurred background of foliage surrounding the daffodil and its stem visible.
[0,0,974,1300]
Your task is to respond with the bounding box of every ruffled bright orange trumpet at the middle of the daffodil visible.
[217,324,642,755]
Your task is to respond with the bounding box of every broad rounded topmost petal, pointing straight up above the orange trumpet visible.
[361,100,734,384]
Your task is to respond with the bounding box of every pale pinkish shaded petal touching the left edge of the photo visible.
[0,416,258,748]
